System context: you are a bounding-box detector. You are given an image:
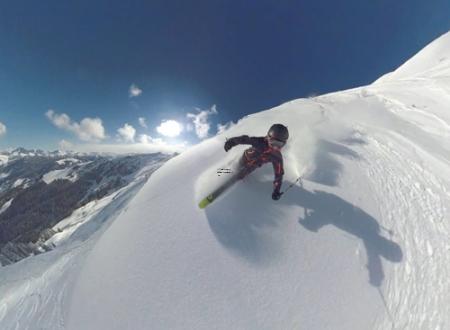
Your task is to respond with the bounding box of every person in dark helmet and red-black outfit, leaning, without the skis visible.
[224,124,289,200]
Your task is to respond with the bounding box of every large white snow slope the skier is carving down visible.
[0,33,450,329]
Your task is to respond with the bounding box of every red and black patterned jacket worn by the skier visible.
[228,135,284,191]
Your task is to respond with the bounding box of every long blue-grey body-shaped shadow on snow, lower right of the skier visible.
[286,187,403,287]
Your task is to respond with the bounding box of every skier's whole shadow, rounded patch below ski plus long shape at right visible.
[206,178,403,287]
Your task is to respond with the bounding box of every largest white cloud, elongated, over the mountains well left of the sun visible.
[45,110,106,141]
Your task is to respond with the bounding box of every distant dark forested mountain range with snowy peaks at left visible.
[0,148,173,265]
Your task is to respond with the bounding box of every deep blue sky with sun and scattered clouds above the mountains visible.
[0,0,450,149]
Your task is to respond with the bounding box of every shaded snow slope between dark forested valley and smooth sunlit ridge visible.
[0,155,170,330]
